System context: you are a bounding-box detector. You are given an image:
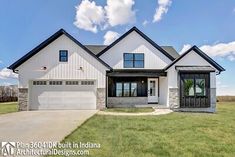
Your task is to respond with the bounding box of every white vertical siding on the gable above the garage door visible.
[16,35,108,88]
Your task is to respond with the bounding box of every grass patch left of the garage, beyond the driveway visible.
[0,102,18,114]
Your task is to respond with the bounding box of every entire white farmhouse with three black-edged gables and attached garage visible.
[9,27,224,112]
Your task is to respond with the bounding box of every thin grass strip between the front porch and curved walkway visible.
[104,107,154,113]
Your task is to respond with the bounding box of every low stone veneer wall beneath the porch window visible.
[107,97,148,107]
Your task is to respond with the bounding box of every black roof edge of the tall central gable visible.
[97,27,175,61]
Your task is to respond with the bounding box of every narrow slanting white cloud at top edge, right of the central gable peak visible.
[153,0,172,22]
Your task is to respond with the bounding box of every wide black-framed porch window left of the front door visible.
[116,82,137,97]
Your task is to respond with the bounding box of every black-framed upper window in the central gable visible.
[124,53,144,68]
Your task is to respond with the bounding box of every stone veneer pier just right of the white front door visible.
[169,88,180,109]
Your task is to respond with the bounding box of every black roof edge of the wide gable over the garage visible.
[8,29,112,71]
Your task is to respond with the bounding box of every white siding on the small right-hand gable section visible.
[167,50,218,106]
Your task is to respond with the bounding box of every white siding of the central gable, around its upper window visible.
[100,31,171,69]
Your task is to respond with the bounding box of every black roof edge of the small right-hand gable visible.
[165,45,225,72]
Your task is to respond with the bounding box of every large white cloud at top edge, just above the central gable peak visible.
[104,0,135,26]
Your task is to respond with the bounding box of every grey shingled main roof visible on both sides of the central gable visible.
[84,45,180,58]
